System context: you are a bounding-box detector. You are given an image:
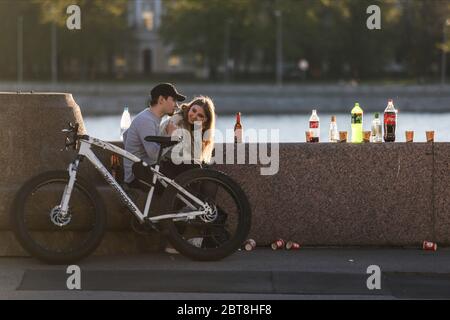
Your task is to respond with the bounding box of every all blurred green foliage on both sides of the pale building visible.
[0,0,450,80]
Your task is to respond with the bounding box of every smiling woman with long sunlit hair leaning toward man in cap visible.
[160,96,216,169]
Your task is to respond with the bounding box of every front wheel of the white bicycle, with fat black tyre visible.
[11,171,106,264]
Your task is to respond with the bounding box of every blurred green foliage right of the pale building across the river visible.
[161,0,450,79]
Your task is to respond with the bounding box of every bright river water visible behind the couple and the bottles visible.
[84,113,450,142]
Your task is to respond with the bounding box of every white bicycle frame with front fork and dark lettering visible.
[60,137,211,223]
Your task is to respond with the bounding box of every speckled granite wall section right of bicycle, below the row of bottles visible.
[86,143,442,246]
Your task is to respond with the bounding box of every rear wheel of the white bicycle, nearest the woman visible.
[161,169,251,261]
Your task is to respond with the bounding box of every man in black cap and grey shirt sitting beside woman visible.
[123,83,186,191]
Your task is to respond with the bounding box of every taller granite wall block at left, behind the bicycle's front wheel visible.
[0,92,159,256]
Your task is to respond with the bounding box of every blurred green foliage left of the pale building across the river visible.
[0,0,131,80]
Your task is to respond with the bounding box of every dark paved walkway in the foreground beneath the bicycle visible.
[0,248,450,300]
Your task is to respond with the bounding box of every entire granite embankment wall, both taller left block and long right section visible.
[0,93,450,255]
